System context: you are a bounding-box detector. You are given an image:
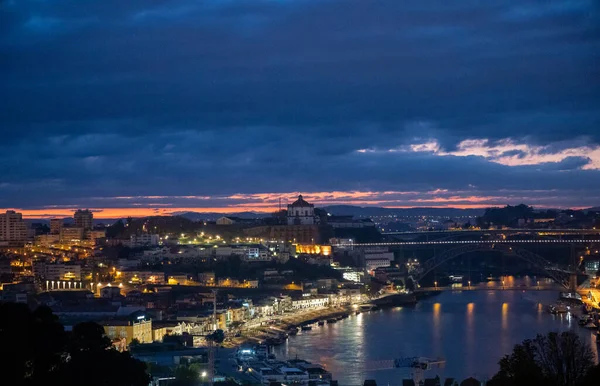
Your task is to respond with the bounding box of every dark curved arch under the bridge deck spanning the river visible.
[415,244,571,289]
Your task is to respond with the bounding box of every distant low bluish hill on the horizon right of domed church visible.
[323,205,485,217]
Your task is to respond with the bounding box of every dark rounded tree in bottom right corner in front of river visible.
[488,331,600,386]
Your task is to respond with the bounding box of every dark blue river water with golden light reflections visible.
[275,290,597,386]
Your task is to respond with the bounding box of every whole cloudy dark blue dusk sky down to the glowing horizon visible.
[0,0,600,217]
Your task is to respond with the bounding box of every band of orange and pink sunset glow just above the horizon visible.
[2,189,576,219]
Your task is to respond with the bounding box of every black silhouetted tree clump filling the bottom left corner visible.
[0,303,150,386]
